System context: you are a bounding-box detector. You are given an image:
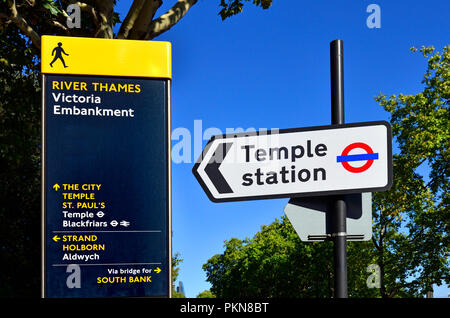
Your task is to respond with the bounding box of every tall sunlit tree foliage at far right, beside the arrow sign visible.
[373,46,450,297]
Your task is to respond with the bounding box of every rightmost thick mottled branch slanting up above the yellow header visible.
[144,0,197,40]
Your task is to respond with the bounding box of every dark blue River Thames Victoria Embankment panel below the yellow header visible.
[43,75,171,297]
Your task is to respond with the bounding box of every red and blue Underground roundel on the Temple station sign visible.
[336,142,378,173]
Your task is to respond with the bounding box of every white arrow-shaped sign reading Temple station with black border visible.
[193,121,392,202]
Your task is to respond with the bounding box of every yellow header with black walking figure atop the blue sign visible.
[41,35,172,79]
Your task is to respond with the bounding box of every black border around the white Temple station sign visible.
[192,120,393,203]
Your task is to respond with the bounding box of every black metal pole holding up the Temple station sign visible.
[330,40,348,298]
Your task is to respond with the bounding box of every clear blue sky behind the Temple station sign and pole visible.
[118,0,450,297]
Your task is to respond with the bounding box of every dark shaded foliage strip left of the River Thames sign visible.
[0,27,41,296]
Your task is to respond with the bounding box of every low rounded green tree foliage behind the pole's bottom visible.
[203,216,376,298]
